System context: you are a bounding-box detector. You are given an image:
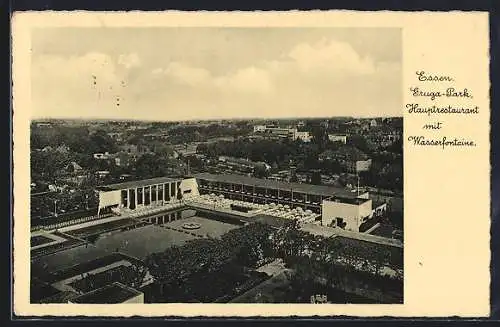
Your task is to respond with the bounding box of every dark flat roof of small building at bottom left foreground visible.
[71,282,142,304]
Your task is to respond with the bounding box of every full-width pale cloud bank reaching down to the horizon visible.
[32,39,402,120]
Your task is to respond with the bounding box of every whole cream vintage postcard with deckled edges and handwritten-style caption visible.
[12,11,490,317]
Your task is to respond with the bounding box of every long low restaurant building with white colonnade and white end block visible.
[99,173,374,231]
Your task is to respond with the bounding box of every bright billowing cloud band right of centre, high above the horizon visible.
[151,40,376,95]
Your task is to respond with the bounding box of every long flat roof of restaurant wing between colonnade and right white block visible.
[194,173,357,199]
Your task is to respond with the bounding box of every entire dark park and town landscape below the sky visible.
[30,117,404,303]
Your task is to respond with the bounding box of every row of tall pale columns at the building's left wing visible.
[121,182,180,209]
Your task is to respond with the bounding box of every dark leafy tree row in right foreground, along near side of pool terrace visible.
[146,221,402,304]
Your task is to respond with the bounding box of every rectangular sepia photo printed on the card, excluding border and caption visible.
[26,26,405,304]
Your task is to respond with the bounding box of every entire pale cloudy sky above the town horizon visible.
[31,27,402,120]
